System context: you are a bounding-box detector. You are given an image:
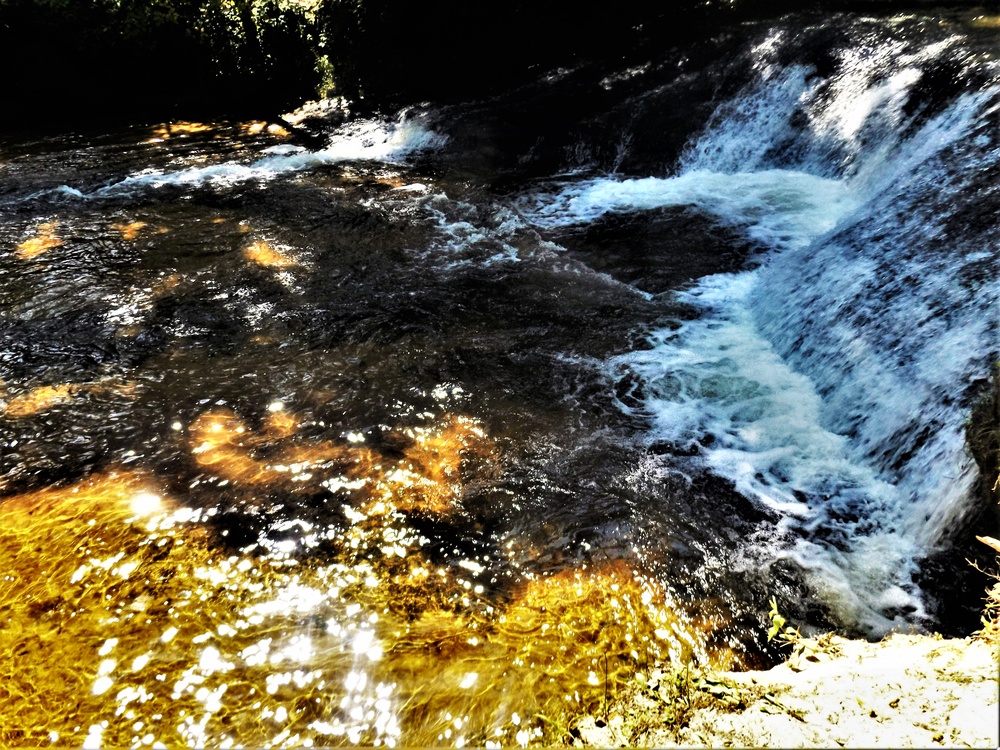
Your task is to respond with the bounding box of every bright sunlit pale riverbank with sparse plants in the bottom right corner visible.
[574,634,1000,747]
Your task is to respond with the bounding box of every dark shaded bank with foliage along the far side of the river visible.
[0,0,992,131]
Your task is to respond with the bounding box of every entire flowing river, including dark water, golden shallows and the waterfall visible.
[0,7,1000,747]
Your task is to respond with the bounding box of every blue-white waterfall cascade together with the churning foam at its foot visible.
[524,33,1000,635]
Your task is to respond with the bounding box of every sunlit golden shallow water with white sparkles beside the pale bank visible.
[0,412,727,747]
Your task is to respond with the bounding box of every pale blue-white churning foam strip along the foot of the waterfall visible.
[612,270,940,632]
